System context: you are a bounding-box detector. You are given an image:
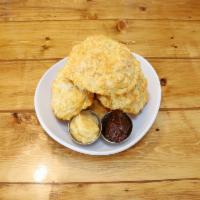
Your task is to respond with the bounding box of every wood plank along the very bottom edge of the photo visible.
[0,180,200,200]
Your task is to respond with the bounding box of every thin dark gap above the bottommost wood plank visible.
[0,178,200,185]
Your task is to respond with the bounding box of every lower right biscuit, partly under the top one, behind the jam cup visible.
[97,73,148,115]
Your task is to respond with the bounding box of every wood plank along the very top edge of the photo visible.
[0,0,200,21]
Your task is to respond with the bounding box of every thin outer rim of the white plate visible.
[34,53,161,156]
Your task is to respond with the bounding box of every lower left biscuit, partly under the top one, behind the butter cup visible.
[51,69,93,120]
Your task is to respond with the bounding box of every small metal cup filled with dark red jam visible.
[102,110,132,143]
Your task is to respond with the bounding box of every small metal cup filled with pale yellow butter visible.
[70,111,100,144]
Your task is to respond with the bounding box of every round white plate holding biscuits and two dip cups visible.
[34,53,161,155]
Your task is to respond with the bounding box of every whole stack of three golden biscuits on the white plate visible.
[52,35,148,120]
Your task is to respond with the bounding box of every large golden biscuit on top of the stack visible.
[66,36,140,95]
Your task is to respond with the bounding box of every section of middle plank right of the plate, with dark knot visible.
[150,59,200,109]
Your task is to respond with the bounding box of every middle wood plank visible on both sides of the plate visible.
[0,59,200,110]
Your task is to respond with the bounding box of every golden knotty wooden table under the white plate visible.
[0,0,200,200]
